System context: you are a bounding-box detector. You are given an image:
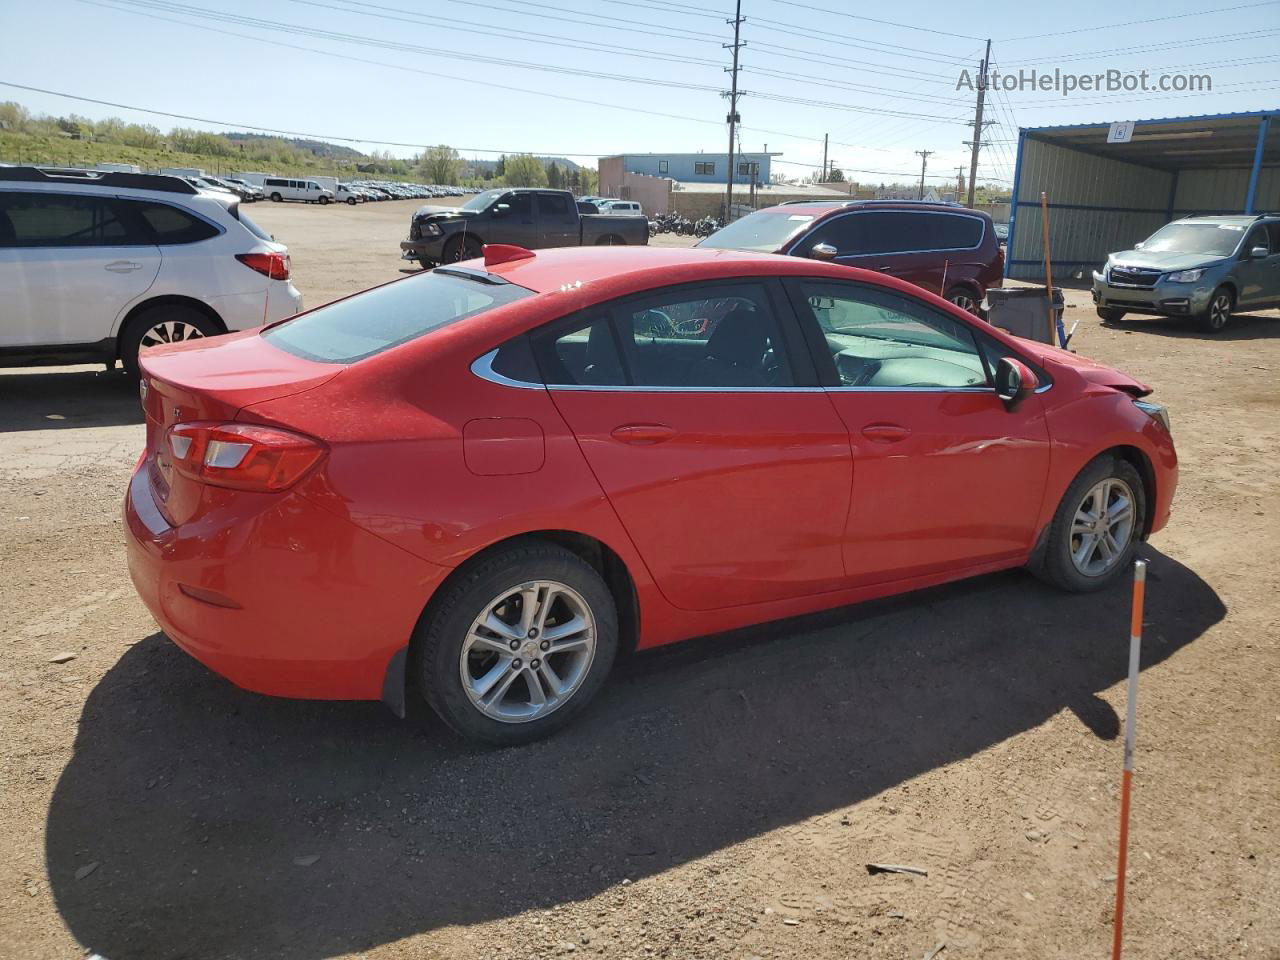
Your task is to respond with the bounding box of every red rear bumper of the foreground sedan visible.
[124,461,449,700]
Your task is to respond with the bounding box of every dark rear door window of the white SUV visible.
[0,192,135,247]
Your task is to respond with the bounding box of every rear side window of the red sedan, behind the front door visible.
[535,284,795,389]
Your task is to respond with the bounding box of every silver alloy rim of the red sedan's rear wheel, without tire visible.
[458,580,596,723]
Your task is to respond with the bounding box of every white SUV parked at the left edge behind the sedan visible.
[0,166,302,374]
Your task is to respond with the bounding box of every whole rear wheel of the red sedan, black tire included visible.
[415,539,618,746]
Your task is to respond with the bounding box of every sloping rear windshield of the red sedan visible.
[262,271,534,364]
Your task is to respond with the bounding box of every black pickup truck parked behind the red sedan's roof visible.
[401,188,649,266]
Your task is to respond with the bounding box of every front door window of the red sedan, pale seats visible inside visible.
[796,280,988,389]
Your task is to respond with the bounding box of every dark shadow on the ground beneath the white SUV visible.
[0,367,142,433]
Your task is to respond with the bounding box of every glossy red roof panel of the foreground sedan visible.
[460,246,847,297]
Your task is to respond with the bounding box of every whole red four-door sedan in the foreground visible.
[124,246,1178,744]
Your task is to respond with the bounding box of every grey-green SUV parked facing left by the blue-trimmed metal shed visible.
[1093,214,1280,333]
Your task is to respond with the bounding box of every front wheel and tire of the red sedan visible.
[1037,456,1147,593]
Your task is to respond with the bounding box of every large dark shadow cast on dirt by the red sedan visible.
[47,552,1225,960]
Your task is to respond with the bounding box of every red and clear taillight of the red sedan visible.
[165,422,326,493]
